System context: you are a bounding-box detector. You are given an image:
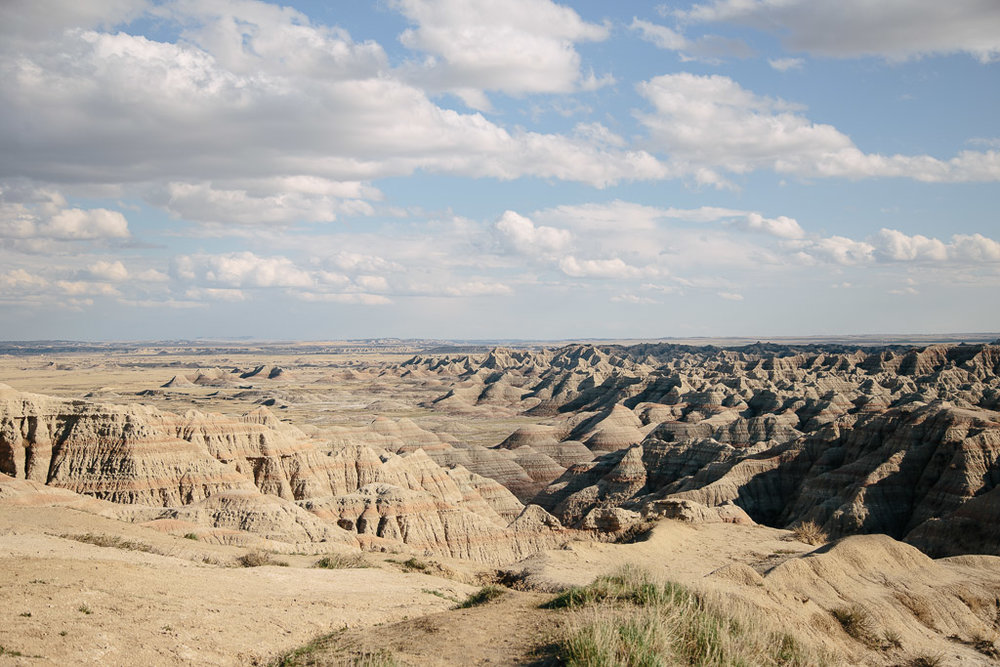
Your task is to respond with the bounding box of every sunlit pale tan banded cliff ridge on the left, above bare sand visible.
[0,387,565,563]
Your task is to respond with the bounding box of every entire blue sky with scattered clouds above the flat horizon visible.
[0,0,1000,340]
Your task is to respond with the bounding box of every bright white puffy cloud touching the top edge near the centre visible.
[393,0,608,109]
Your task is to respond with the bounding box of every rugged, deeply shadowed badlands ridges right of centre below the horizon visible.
[400,344,1000,555]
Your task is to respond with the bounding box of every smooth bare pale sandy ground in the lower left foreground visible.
[0,508,475,665]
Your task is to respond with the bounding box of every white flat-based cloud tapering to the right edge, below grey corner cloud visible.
[637,73,1000,182]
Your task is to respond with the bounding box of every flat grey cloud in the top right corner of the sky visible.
[676,0,1000,63]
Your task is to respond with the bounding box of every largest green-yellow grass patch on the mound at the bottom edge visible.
[544,568,814,666]
